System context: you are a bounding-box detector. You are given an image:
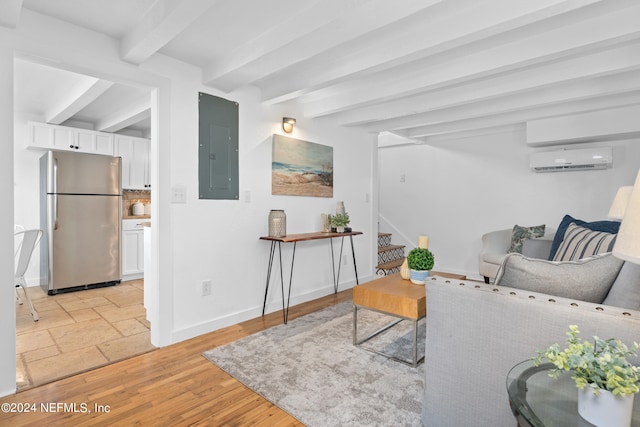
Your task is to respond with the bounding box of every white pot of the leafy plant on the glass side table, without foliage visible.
[578,387,635,427]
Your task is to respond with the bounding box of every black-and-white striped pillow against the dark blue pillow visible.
[553,223,617,261]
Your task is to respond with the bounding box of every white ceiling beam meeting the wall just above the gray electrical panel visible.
[203,0,442,91]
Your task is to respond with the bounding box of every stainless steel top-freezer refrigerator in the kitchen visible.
[40,151,122,295]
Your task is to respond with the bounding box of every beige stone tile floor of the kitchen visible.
[16,279,155,390]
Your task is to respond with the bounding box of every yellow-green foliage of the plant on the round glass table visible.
[533,325,640,396]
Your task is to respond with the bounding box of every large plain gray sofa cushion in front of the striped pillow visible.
[495,253,624,303]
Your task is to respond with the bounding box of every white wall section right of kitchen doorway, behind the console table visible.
[140,54,376,340]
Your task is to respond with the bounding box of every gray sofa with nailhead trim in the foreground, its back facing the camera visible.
[422,254,640,427]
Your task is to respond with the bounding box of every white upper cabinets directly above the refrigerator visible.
[27,122,113,156]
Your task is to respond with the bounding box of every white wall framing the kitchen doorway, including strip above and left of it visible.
[0,11,377,394]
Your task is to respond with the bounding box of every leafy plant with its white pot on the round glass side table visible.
[533,325,640,426]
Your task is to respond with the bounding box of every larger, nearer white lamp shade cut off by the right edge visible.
[613,172,640,264]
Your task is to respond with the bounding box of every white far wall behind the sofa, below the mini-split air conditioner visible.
[378,130,640,279]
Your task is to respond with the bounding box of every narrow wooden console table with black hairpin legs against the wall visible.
[260,231,362,324]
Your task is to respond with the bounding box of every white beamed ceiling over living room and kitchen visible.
[7,0,640,141]
